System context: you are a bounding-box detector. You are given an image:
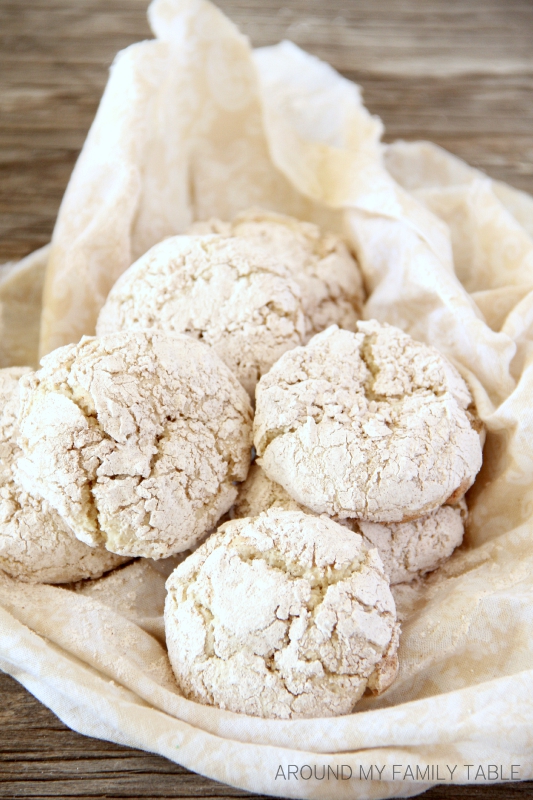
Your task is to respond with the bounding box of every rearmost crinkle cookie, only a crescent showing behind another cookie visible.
[191,209,364,341]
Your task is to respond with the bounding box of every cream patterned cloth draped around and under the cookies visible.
[0,0,533,800]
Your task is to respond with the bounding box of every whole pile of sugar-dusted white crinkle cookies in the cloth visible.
[0,211,483,719]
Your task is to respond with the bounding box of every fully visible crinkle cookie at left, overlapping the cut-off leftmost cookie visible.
[14,331,252,558]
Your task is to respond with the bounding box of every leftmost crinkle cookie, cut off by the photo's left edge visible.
[0,367,127,583]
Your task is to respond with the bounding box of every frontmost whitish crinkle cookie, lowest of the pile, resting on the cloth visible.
[165,508,398,719]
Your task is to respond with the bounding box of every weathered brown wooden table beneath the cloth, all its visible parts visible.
[0,0,533,800]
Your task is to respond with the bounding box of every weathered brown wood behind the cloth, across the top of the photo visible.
[0,0,533,261]
